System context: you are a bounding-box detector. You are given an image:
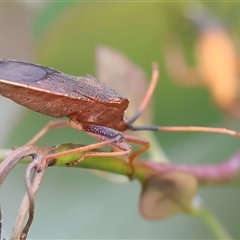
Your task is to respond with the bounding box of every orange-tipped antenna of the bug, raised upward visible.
[128,63,159,125]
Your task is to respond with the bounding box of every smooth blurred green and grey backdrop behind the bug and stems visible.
[0,1,240,239]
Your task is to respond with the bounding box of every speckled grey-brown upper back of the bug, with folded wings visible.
[0,59,128,107]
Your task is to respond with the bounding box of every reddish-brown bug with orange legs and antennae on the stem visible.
[0,59,240,169]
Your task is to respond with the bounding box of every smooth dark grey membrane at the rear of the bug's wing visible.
[0,59,57,83]
